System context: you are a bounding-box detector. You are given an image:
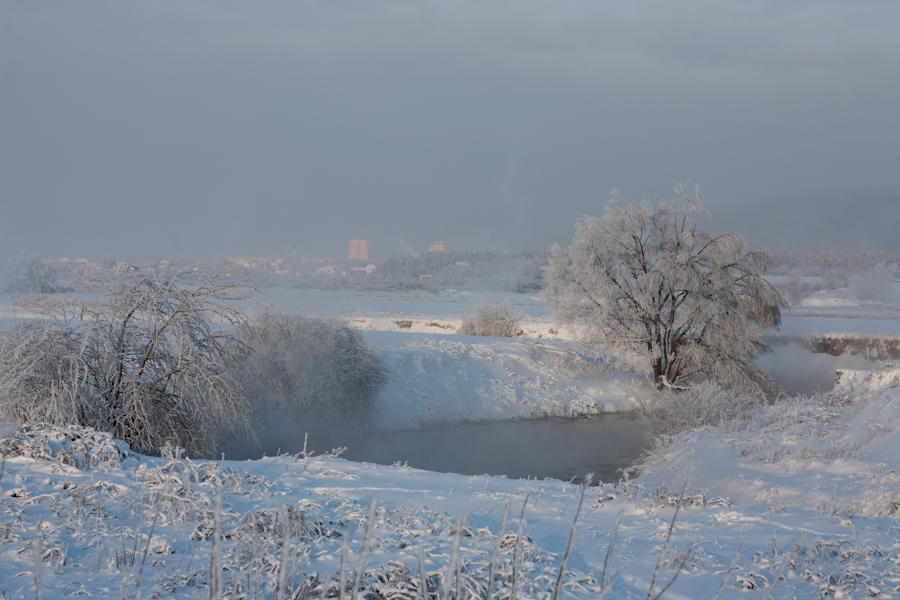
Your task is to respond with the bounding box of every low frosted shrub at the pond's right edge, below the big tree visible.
[634,381,758,442]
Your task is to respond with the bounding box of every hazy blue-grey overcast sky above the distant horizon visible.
[0,0,900,260]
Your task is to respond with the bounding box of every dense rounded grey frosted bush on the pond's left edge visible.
[234,311,388,428]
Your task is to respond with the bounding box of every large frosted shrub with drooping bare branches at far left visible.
[0,271,249,456]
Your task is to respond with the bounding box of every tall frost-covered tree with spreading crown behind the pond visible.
[544,183,787,397]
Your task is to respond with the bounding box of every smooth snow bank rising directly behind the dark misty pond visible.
[366,332,651,431]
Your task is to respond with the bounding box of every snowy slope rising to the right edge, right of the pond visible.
[639,366,900,518]
